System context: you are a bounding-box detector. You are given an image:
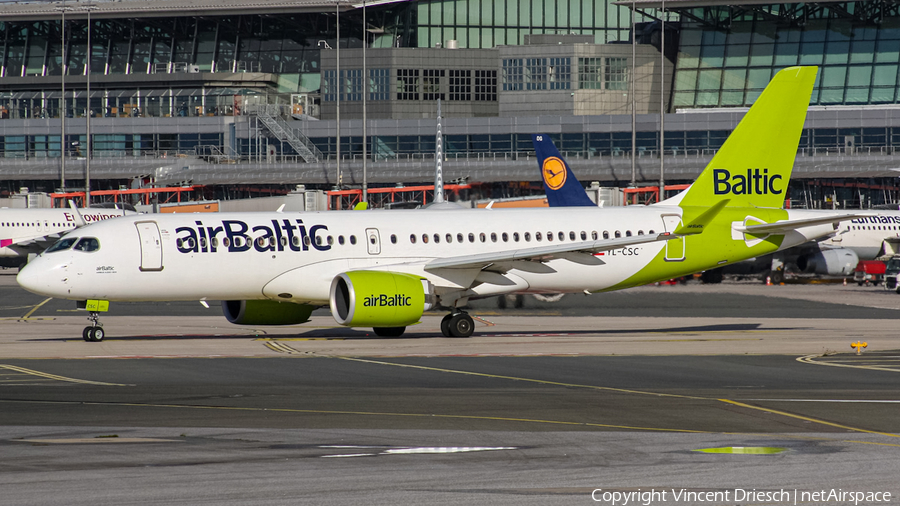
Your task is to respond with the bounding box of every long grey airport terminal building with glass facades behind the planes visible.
[0,0,900,207]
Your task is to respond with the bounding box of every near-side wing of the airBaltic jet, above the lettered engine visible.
[425,232,678,271]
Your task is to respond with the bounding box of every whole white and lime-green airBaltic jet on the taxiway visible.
[18,67,847,341]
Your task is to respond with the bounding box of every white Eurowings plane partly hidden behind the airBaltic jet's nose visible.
[0,208,125,267]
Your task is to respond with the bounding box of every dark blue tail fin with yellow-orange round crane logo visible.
[531,134,597,207]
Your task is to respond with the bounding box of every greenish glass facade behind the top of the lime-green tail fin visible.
[672,7,900,108]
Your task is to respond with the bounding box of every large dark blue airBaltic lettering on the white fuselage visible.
[175,218,331,253]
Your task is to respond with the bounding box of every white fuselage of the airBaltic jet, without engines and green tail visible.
[19,206,833,304]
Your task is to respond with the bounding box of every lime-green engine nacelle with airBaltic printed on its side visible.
[329,271,434,327]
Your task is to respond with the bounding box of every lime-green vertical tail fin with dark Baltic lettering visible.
[680,67,818,208]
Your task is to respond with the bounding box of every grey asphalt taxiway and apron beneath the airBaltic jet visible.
[0,275,900,505]
